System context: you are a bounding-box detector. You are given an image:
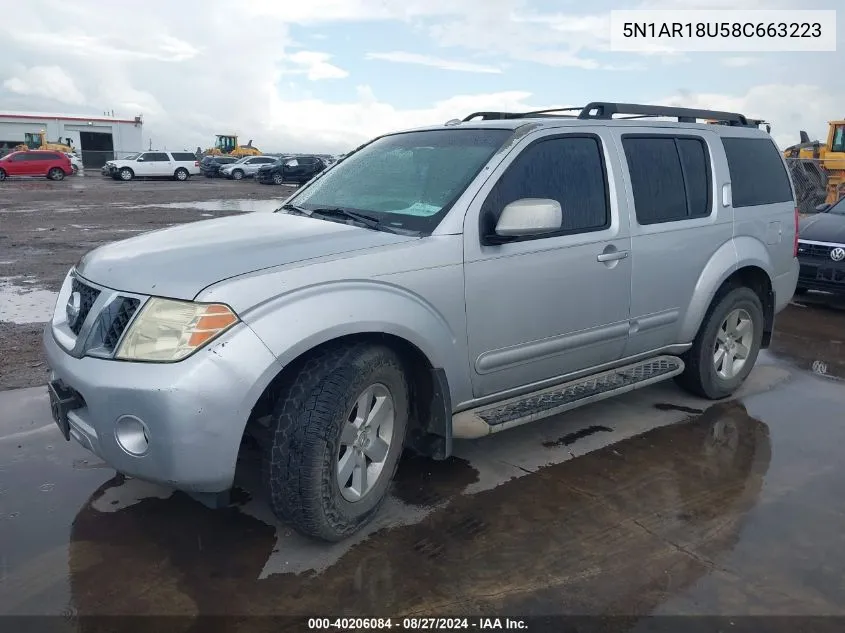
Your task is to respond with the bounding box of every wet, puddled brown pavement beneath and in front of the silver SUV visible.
[0,177,845,631]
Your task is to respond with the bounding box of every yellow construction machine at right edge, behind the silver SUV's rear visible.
[783,120,845,213]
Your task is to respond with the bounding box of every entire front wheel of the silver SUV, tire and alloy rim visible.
[264,344,409,542]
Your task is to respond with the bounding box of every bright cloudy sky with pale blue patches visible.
[0,0,845,153]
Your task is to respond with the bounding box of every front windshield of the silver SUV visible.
[290,129,513,233]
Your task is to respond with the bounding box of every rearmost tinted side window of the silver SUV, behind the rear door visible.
[722,138,792,207]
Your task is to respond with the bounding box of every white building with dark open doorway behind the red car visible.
[0,111,144,167]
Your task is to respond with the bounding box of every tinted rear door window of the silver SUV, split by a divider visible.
[622,134,712,225]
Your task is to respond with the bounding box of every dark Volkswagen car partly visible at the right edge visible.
[795,198,845,294]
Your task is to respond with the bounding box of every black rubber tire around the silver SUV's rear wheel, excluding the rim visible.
[675,286,764,400]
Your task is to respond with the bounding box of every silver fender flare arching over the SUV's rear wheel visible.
[679,236,773,343]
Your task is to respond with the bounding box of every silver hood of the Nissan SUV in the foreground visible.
[77,213,417,299]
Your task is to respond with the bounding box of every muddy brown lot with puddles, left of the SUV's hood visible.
[0,172,293,391]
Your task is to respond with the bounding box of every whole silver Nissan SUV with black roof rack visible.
[44,103,798,541]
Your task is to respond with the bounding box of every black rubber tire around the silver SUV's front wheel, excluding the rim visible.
[263,344,409,542]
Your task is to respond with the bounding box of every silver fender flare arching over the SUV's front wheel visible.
[234,280,468,391]
